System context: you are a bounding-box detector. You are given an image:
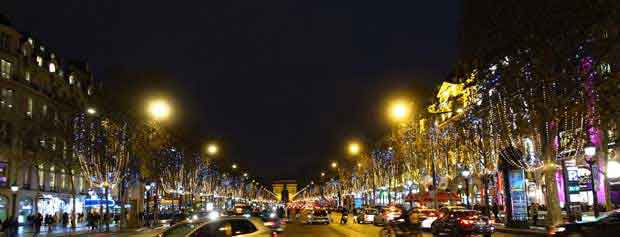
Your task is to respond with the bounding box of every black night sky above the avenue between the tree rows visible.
[0,0,460,181]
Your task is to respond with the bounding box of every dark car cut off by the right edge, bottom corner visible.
[555,210,620,237]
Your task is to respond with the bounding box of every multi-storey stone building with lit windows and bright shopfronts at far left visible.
[0,14,95,223]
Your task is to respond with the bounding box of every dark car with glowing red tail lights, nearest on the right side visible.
[431,209,495,237]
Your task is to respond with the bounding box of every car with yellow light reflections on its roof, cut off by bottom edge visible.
[158,217,273,237]
